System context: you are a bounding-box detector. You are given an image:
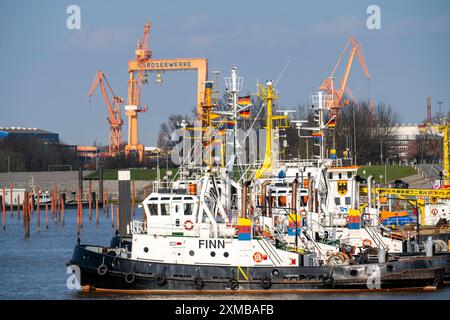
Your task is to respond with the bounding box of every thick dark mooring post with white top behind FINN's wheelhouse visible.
[117,170,131,236]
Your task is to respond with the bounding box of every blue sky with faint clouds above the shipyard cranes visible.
[0,0,450,146]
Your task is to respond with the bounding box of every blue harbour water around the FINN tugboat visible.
[0,209,450,300]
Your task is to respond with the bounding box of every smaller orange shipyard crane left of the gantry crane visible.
[89,71,124,157]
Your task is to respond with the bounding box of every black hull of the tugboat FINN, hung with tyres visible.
[68,245,447,293]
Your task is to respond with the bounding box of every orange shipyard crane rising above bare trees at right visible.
[319,36,373,115]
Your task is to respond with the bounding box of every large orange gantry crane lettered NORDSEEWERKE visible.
[125,22,208,162]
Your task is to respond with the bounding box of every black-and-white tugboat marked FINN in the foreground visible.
[68,172,445,293]
